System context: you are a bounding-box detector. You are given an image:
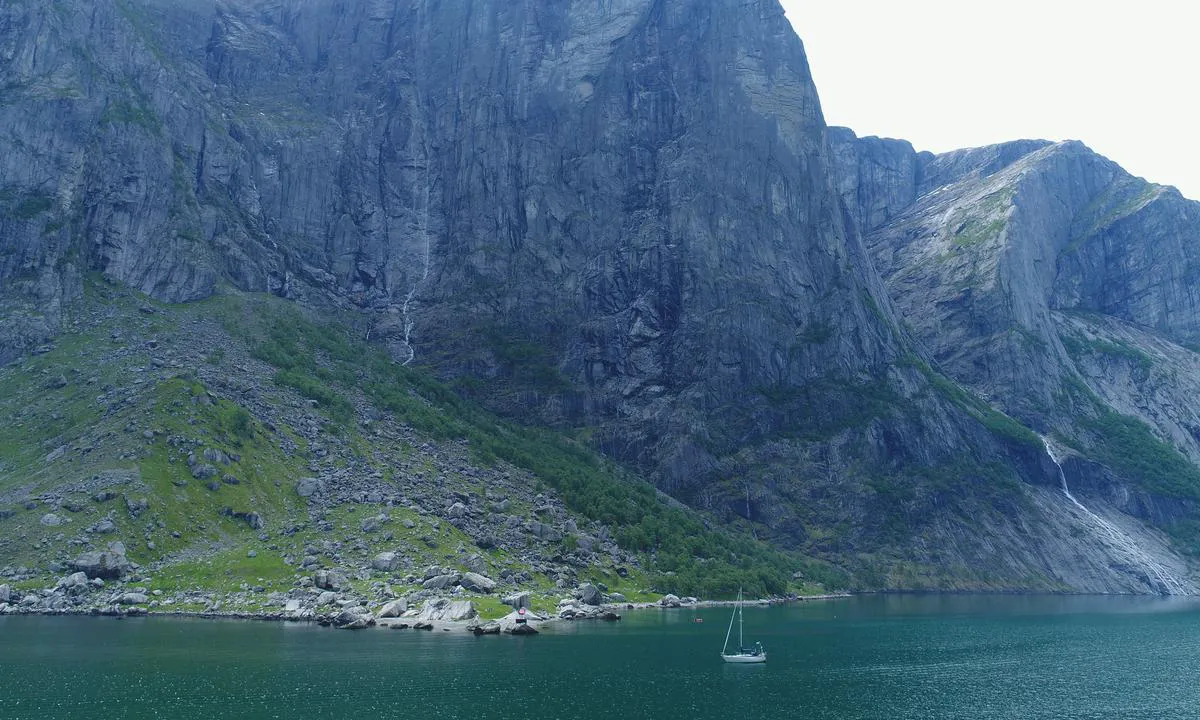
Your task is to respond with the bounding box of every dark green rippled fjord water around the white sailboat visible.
[0,595,1200,720]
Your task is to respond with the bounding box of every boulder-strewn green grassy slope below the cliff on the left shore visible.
[0,281,839,608]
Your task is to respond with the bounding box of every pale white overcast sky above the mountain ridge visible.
[782,0,1200,199]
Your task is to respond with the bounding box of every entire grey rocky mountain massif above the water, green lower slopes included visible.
[0,0,1200,607]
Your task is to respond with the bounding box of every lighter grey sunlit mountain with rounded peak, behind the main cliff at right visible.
[836,125,1200,573]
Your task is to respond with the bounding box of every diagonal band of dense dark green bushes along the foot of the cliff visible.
[221,292,816,596]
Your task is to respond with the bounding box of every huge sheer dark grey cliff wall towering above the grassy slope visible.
[2,0,936,484]
